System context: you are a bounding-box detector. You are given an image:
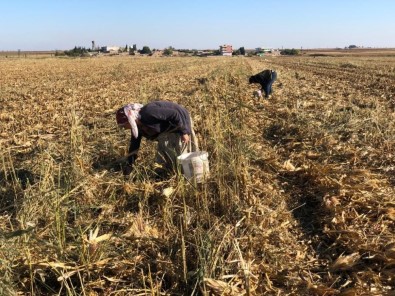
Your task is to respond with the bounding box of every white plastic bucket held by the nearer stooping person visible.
[177,151,210,183]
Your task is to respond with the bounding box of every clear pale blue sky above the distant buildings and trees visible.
[0,0,395,51]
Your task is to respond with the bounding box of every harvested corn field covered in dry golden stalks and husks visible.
[0,56,395,295]
